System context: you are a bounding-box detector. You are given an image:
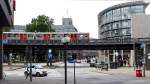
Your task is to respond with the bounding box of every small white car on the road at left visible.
[24,64,48,77]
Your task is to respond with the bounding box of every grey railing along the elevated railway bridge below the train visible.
[3,38,150,45]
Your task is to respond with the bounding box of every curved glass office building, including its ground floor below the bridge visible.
[98,1,148,67]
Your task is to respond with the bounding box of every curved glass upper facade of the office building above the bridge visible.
[98,3,146,38]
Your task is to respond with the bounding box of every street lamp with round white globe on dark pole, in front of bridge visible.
[61,36,70,84]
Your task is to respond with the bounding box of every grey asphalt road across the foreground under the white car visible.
[0,68,150,84]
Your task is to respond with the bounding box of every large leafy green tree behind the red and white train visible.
[26,15,54,32]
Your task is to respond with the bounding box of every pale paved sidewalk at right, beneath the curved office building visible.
[91,67,150,77]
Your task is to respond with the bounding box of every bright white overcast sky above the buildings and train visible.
[14,0,150,38]
